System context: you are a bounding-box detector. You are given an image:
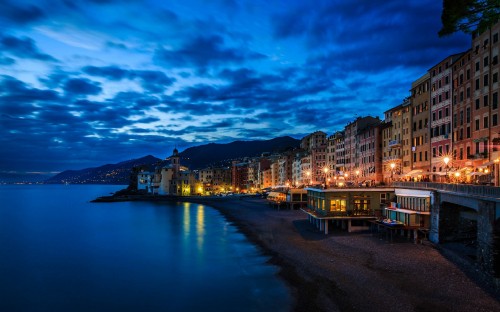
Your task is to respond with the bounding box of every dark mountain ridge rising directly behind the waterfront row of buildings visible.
[179,136,300,169]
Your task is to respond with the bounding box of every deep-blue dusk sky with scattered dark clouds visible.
[0,0,470,172]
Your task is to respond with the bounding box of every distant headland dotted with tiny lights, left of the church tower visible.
[45,155,161,185]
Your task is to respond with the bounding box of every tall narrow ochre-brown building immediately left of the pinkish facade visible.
[405,73,431,181]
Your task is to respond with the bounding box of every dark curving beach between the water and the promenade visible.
[189,197,500,312]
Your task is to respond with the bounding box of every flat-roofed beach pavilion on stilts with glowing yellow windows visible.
[302,187,394,234]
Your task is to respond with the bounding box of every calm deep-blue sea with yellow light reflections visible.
[0,185,291,312]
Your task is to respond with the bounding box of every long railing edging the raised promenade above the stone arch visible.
[392,182,500,199]
